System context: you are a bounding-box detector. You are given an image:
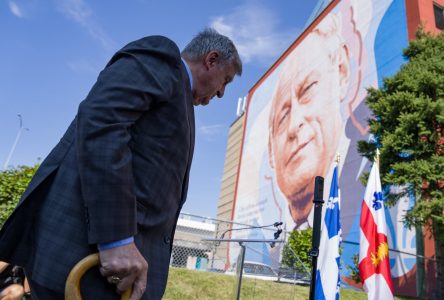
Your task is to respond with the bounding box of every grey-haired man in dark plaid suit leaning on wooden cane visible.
[0,29,242,300]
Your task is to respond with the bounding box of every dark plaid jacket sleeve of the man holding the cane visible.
[77,37,180,244]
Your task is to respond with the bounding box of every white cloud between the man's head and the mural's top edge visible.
[211,2,300,64]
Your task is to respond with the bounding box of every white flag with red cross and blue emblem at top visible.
[359,163,393,300]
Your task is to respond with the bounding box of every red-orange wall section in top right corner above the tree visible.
[405,0,444,40]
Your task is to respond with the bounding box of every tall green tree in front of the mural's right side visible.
[358,29,444,299]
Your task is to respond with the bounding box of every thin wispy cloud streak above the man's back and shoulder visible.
[55,0,115,50]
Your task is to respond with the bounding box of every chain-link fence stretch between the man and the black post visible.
[170,213,310,294]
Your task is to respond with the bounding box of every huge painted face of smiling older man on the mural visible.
[269,27,349,223]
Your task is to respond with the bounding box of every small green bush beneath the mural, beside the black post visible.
[282,228,313,272]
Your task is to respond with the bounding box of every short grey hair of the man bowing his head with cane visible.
[181,28,242,76]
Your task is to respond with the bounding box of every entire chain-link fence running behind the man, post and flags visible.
[170,213,437,299]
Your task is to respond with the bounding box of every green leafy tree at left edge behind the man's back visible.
[0,164,39,227]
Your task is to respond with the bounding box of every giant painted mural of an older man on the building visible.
[229,0,416,296]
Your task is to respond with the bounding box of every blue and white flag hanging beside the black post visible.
[315,166,342,300]
